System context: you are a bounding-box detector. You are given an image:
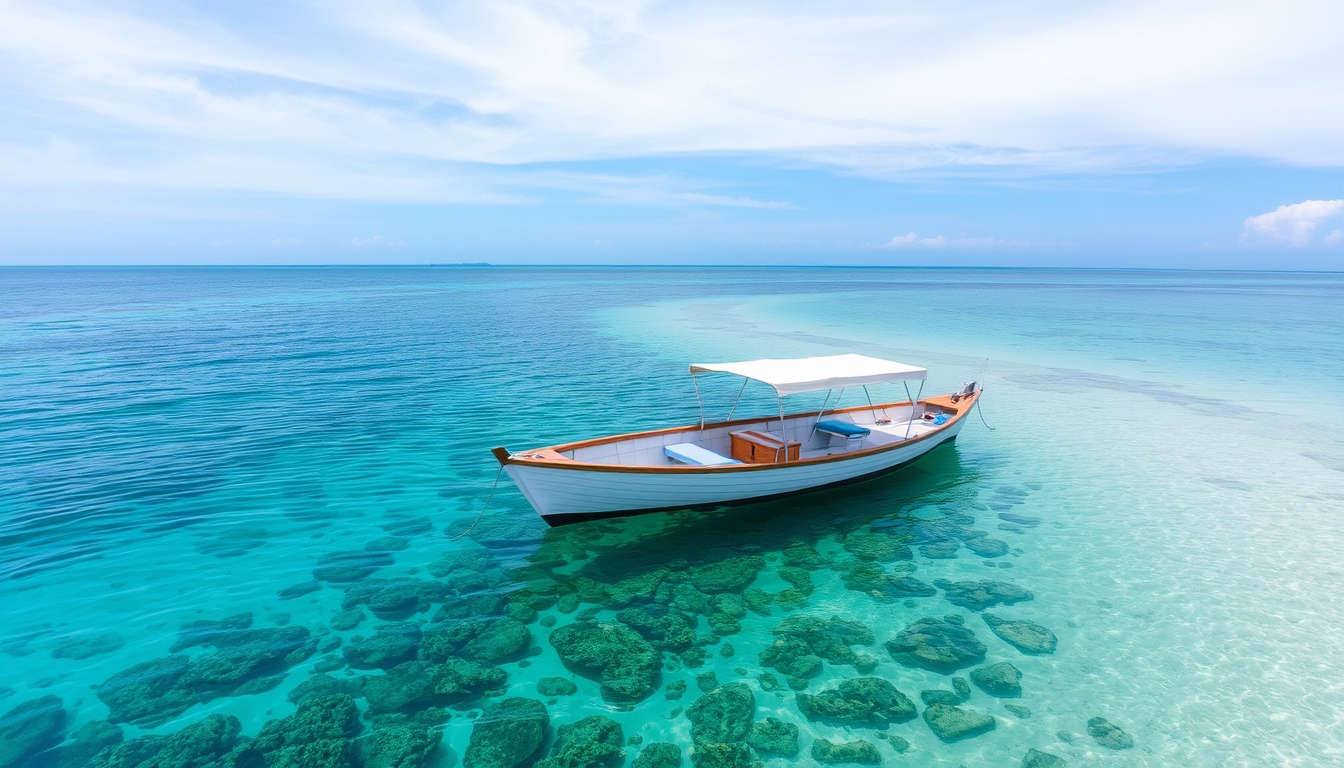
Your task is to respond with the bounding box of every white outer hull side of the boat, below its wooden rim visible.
[504,409,969,526]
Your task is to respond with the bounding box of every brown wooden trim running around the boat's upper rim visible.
[492,390,980,475]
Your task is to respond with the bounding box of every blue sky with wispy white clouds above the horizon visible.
[0,0,1344,270]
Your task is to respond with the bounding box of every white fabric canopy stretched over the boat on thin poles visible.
[691,355,929,394]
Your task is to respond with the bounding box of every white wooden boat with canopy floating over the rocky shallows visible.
[493,354,981,526]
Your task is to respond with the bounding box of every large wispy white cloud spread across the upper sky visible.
[0,0,1344,206]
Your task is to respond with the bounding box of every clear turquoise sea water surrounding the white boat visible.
[0,268,1344,768]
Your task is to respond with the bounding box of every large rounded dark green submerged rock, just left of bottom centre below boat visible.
[550,621,661,703]
